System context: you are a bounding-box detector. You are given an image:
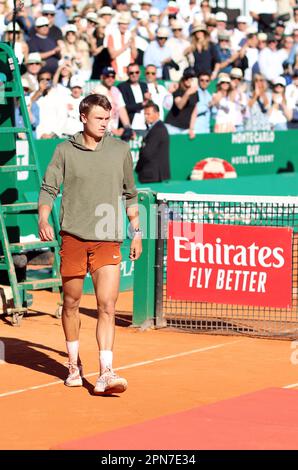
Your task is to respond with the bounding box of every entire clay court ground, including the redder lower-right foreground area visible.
[0,291,298,450]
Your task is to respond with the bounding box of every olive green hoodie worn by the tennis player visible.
[39,132,137,241]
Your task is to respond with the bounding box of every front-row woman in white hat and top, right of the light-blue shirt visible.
[211,73,236,133]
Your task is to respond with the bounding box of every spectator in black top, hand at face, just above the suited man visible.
[165,67,198,138]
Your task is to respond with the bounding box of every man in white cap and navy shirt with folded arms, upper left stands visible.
[28,16,60,74]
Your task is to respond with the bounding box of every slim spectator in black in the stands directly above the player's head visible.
[91,18,111,80]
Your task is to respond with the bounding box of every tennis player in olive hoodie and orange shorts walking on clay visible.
[39,94,142,395]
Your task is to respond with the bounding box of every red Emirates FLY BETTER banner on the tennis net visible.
[167,222,293,308]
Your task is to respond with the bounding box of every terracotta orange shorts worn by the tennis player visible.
[59,231,121,277]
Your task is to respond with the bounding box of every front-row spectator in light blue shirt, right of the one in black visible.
[195,72,211,134]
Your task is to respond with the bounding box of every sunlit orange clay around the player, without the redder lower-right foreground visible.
[0,292,298,449]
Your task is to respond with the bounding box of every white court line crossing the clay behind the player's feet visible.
[0,339,243,398]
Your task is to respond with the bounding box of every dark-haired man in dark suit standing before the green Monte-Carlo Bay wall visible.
[136,101,170,183]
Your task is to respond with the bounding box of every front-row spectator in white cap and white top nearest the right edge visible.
[268,77,293,131]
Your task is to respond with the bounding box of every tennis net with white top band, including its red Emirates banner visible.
[155,193,298,338]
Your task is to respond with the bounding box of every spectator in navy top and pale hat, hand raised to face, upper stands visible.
[184,23,220,75]
